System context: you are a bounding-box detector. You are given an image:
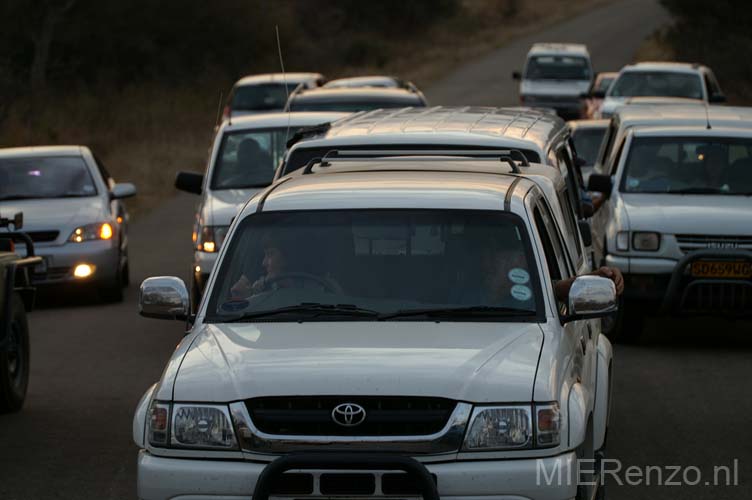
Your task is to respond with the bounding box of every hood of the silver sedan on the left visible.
[0,196,105,232]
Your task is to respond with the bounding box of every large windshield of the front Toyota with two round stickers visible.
[207,209,541,322]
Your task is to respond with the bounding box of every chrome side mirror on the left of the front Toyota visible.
[138,276,191,321]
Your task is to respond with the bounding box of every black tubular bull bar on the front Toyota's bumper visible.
[253,452,439,500]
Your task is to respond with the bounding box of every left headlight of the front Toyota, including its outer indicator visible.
[147,402,238,450]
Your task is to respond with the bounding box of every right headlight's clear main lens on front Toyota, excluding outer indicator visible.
[464,406,533,451]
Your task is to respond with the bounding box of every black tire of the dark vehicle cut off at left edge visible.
[0,293,30,413]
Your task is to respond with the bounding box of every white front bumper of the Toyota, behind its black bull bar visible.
[138,450,577,500]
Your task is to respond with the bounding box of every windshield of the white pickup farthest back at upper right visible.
[609,71,703,99]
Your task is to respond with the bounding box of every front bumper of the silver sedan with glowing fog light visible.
[32,238,121,285]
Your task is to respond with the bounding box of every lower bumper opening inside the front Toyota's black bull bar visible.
[270,471,436,498]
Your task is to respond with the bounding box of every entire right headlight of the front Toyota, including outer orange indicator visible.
[463,403,560,451]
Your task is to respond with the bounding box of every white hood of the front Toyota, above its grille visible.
[173,321,543,402]
